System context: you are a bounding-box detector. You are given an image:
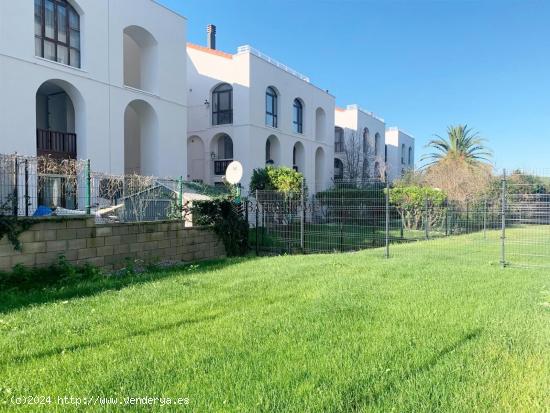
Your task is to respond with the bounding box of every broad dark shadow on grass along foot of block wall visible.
[0,258,253,314]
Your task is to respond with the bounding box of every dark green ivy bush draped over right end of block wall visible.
[192,199,248,257]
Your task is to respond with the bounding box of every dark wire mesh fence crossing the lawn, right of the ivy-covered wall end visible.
[247,170,550,267]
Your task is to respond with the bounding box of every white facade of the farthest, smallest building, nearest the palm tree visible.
[386,127,415,181]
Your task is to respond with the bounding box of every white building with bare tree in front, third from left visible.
[334,105,386,181]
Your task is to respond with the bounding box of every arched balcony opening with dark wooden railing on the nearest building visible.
[35,79,87,159]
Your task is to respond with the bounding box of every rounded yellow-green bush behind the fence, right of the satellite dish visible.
[250,166,304,192]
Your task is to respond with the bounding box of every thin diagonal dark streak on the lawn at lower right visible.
[327,329,482,412]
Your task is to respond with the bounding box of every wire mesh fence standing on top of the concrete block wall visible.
[0,155,229,222]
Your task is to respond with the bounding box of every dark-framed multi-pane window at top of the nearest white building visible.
[34,0,82,69]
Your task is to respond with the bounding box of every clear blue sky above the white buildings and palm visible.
[160,0,550,171]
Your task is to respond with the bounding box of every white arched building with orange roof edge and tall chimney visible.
[187,26,335,192]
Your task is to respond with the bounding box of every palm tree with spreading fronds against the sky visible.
[421,125,493,166]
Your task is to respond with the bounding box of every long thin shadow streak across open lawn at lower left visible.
[0,315,219,366]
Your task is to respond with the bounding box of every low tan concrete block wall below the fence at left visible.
[0,216,225,271]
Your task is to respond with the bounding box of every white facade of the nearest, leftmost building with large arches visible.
[0,0,187,176]
